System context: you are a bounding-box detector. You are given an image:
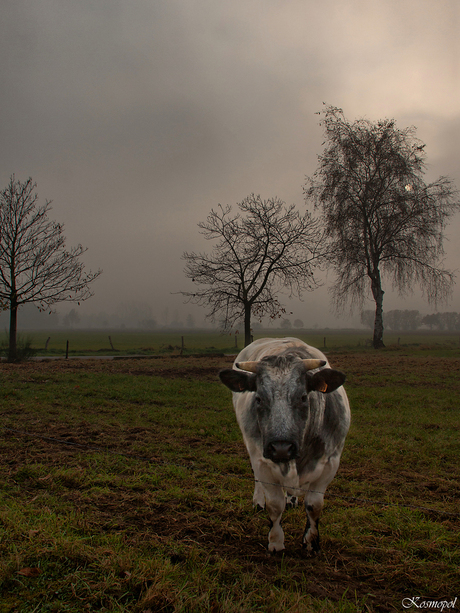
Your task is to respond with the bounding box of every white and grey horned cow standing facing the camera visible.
[219,338,350,555]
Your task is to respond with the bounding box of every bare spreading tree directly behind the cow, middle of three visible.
[181,194,322,344]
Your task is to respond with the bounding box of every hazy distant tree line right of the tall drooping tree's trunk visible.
[361,309,460,332]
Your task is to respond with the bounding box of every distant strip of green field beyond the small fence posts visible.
[4,330,460,357]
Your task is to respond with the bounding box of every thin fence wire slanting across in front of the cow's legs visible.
[3,426,460,518]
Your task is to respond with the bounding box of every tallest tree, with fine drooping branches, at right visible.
[305,106,460,348]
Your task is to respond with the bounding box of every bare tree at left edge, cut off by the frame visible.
[0,175,101,360]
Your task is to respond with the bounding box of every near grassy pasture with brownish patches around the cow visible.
[0,346,460,613]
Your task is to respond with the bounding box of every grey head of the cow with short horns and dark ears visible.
[219,355,345,463]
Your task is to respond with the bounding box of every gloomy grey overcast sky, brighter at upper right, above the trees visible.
[0,0,460,325]
